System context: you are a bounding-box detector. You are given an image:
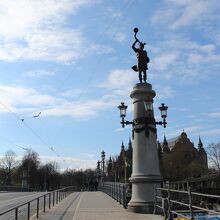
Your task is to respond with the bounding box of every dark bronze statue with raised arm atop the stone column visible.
[132,28,150,83]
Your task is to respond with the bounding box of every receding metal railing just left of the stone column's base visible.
[99,182,128,208]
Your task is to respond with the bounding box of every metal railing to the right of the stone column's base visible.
[154,186,220,220]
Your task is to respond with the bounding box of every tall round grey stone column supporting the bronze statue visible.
[128,83,162,214]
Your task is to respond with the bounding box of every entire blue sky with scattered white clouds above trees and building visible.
[0,0,220,169]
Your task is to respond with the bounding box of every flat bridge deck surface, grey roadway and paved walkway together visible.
[0,187,164,220]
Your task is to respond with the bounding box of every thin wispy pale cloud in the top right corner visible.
[152,0,219,29]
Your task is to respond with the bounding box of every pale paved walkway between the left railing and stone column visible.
[32,192,163,220]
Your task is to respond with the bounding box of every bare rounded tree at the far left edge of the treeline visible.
[0,150,17,185]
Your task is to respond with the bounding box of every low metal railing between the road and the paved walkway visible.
[0,186,74,220]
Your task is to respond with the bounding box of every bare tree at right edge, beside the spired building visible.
[207,142,220,171]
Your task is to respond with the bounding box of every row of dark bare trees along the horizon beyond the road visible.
[0,149,96,191]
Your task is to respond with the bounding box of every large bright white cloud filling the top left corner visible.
[0,0,97,62]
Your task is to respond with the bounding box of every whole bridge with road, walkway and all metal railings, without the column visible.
[0,182,220,220]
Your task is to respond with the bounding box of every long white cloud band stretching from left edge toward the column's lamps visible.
[0,85,119,119]
